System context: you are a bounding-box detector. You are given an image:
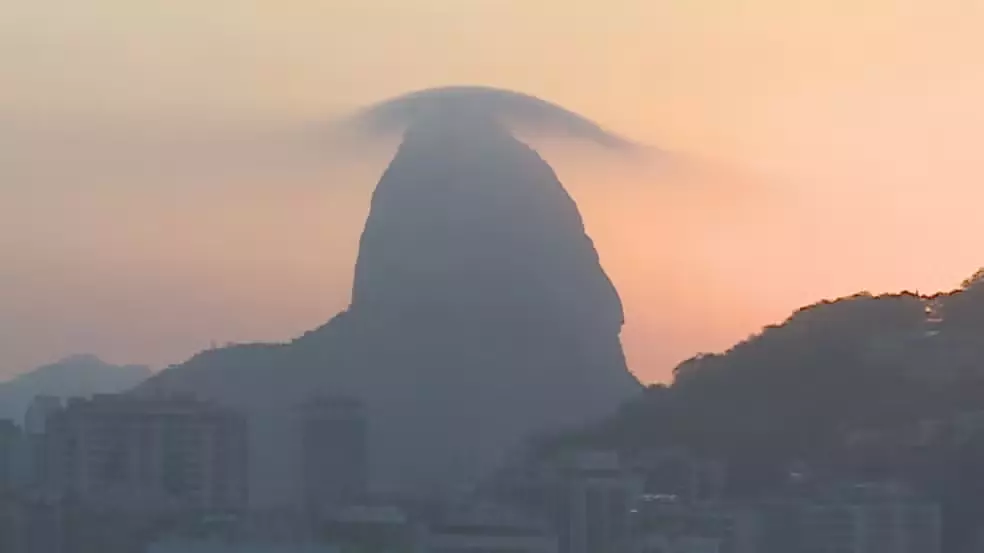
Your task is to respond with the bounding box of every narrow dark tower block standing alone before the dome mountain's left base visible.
[298,397,369,512]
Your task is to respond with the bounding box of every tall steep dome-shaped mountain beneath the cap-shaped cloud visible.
[140,87,641,500]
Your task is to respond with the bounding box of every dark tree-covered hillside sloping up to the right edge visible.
[539,271,984,551]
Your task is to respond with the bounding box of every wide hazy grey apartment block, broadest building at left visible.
[44,395,248,510]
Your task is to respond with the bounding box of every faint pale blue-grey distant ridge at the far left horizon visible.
[0,354,152,423]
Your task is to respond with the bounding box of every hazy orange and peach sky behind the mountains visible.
[0,0,984,382]
